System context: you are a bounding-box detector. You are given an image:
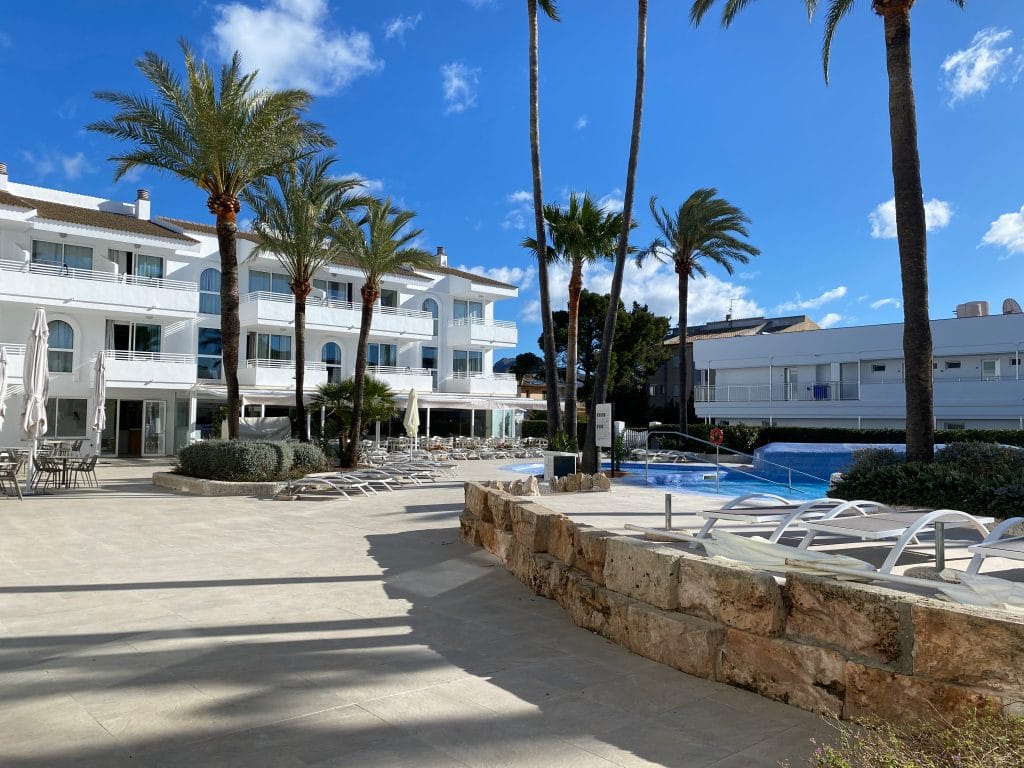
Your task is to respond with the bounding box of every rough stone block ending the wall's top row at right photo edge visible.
[911,600,1024,699]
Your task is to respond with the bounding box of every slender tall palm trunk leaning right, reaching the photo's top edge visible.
[583,0,647,473]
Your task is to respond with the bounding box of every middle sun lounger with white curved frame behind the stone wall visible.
[798,509,992,573]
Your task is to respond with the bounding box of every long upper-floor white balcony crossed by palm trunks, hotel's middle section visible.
[239,291,434,341]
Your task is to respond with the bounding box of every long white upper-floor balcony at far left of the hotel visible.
[0,260,199,317]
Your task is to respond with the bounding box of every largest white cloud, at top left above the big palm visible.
[213,0,383,95]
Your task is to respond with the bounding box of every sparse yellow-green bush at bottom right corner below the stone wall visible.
[794,714,1024,768]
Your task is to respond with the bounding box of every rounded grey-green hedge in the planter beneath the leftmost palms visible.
[178,440,327,482]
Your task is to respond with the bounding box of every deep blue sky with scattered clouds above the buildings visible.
[0,0,1024,358]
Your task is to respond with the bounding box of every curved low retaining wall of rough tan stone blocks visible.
[460,482,1024,722]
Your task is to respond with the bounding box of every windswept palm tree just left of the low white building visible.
[637,188,761,432]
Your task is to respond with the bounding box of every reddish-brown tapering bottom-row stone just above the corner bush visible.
[843,662,1001,723]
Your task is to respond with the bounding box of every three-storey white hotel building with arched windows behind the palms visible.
[0,164,544,456]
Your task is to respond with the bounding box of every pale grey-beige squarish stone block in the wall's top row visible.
[604,537,680,609]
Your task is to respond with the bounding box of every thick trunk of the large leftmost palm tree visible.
[207,195,242,440]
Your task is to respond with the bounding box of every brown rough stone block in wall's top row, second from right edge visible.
[785,573,909,665]
